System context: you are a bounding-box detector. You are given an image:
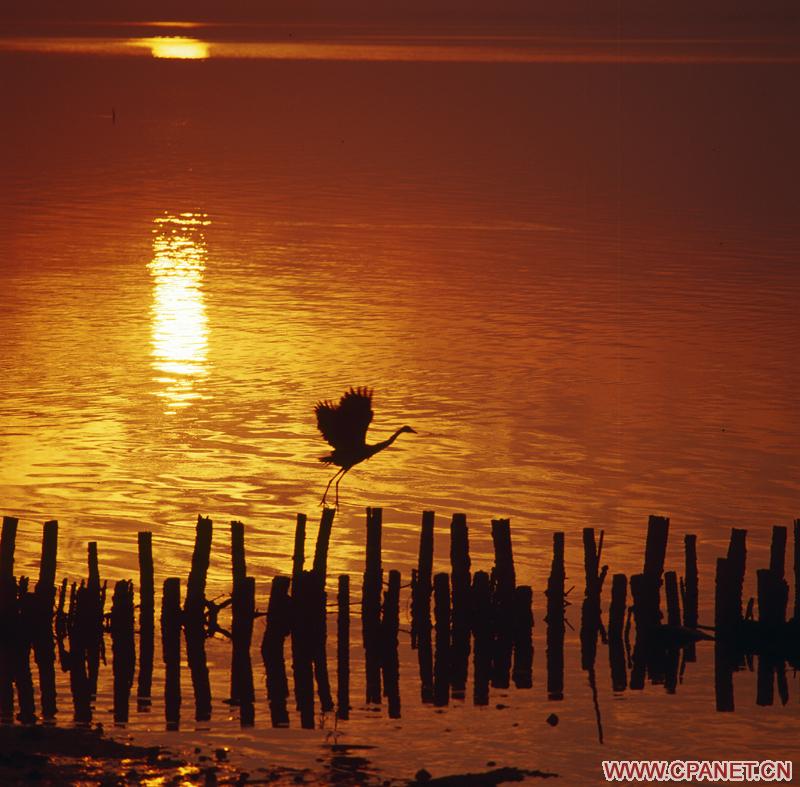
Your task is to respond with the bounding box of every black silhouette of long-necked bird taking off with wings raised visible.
[314,388,416,509]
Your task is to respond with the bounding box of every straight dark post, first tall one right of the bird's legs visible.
[361,508,383,703]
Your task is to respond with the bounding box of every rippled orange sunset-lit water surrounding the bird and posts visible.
[0,21,800,783]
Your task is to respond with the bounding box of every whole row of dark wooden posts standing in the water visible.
[0,509,800,737]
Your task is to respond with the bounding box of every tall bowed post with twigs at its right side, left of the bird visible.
[183,516,212,721]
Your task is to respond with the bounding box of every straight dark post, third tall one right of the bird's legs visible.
[450,514,472,699]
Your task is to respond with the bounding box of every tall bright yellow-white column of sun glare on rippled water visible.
[147,213,211,413]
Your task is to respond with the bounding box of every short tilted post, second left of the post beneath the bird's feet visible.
[261,576,292,727]
